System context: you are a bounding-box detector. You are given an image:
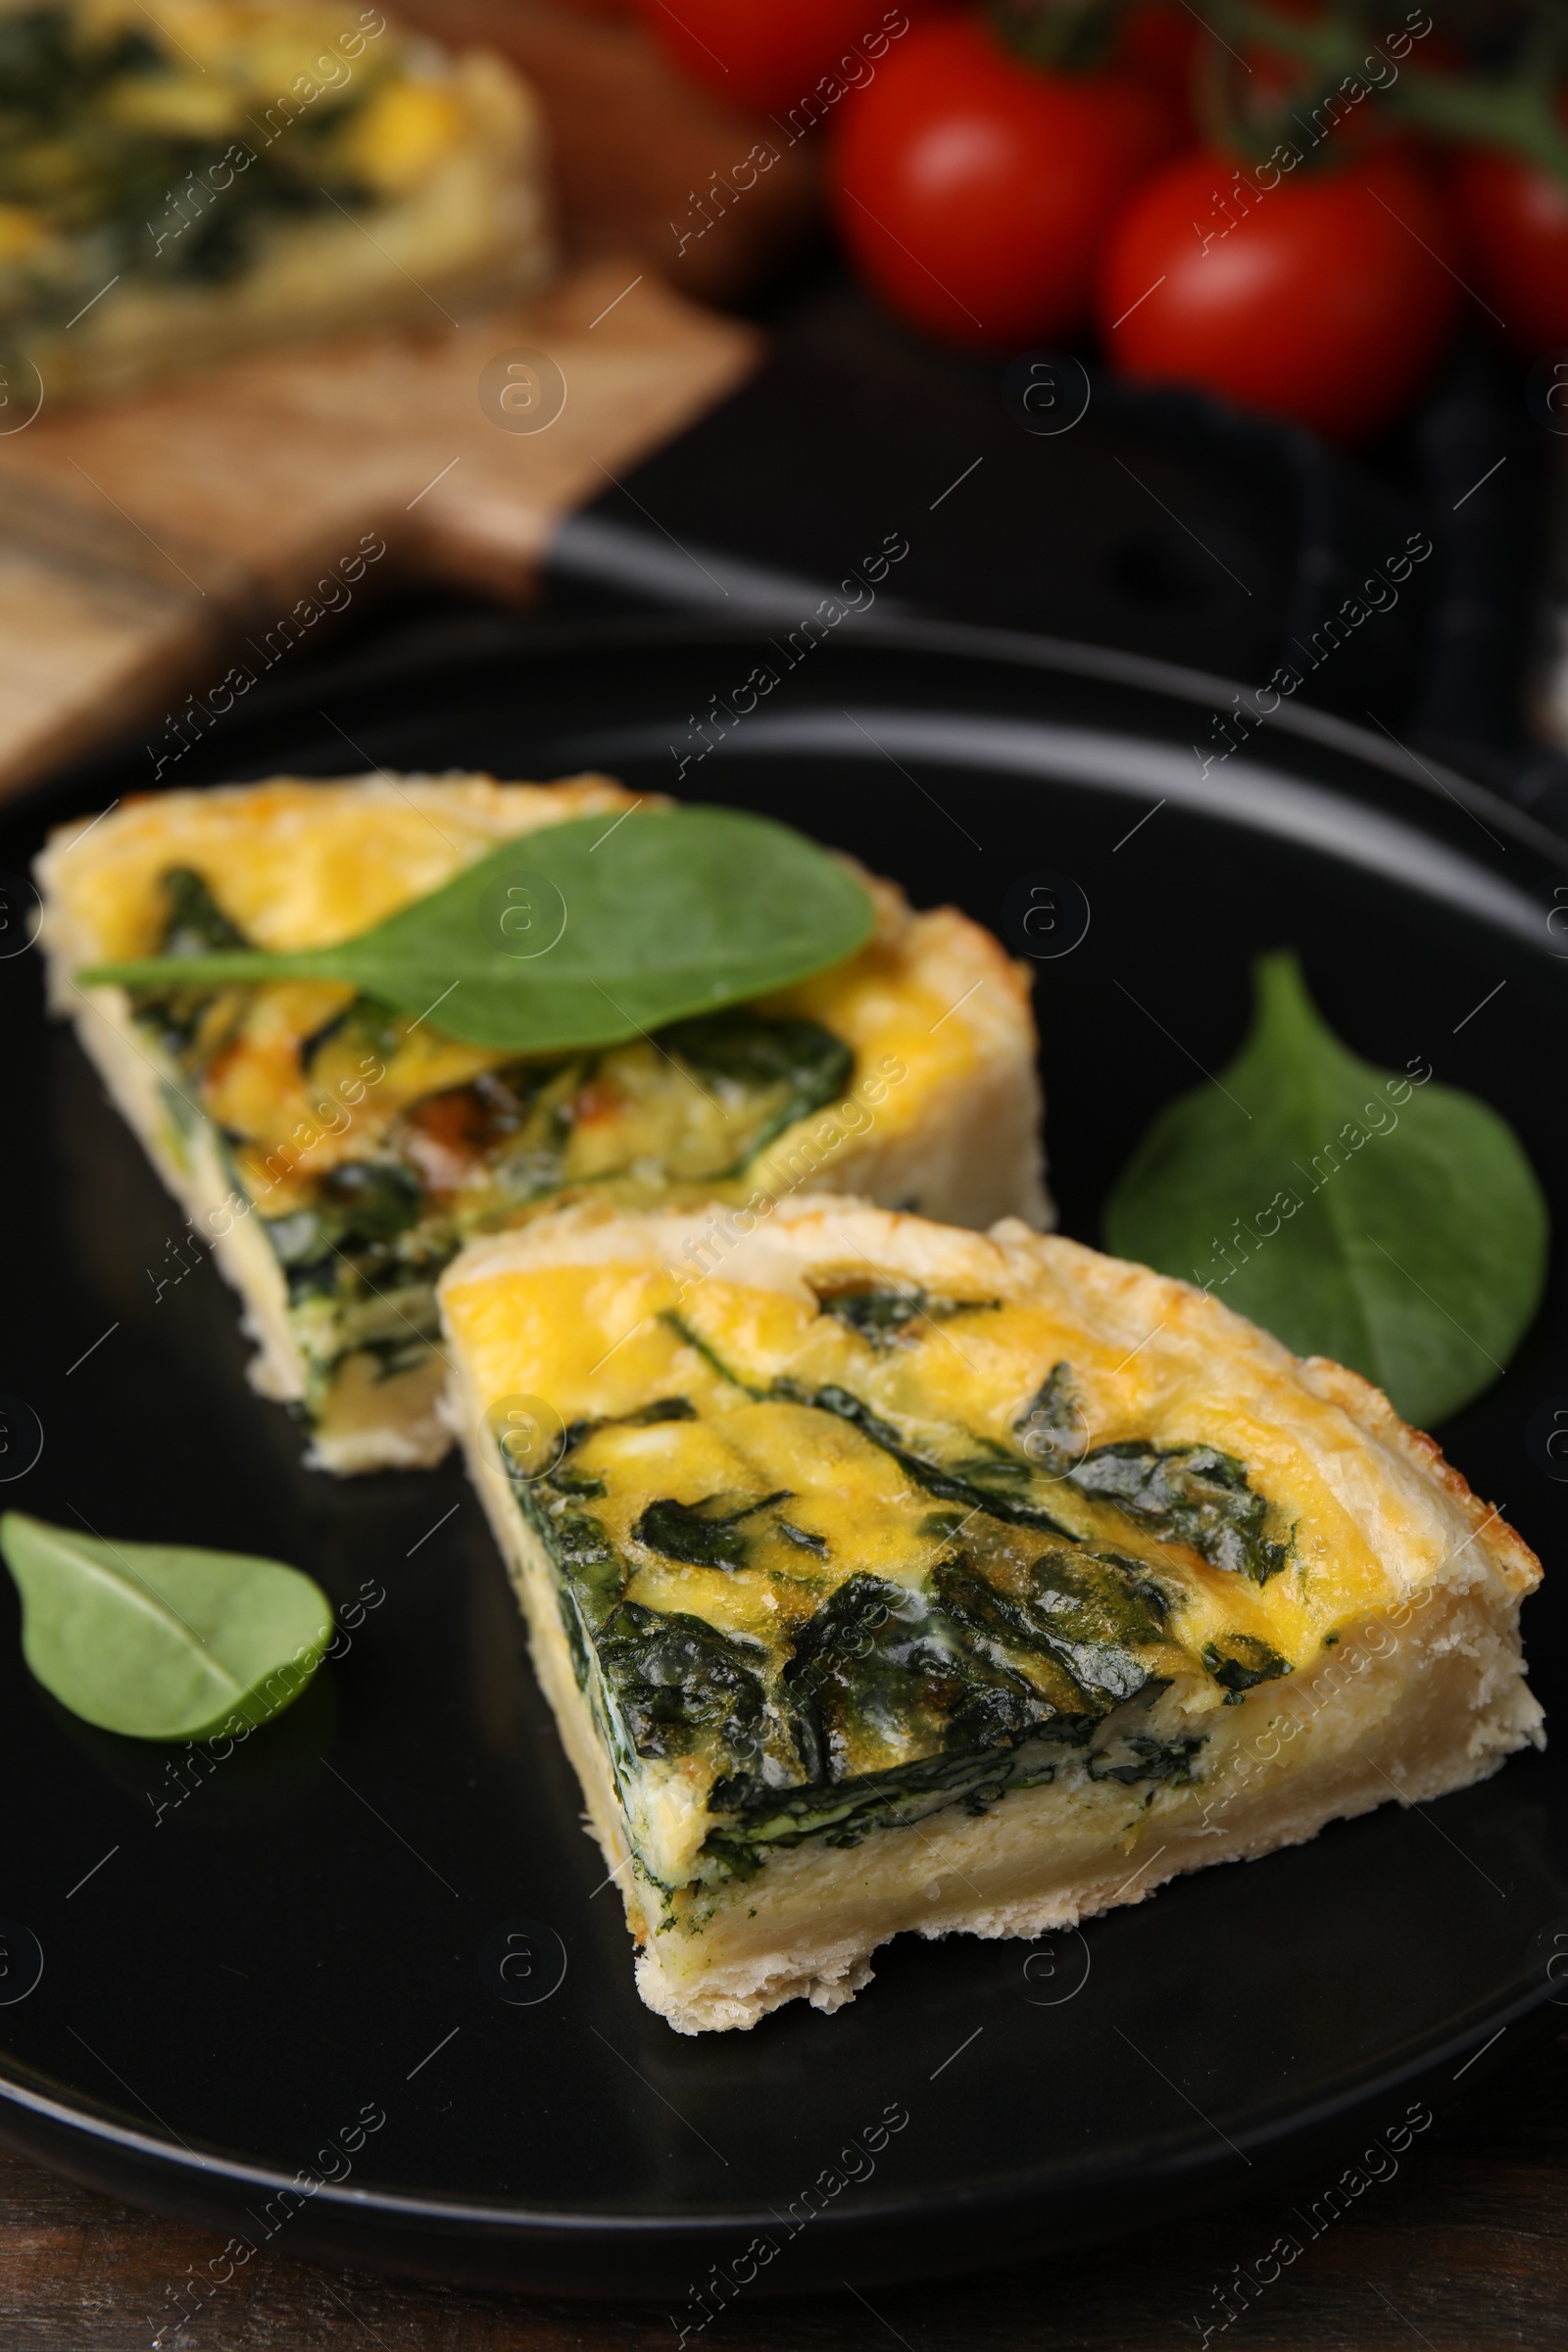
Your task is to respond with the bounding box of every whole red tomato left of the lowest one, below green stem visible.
[830,17,1180,346]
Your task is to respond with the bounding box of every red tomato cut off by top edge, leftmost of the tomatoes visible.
[642,0,917,116]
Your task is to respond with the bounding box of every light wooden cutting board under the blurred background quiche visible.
[0,261,760,790]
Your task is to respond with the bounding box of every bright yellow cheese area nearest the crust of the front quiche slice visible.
[447,1265,1394,1658]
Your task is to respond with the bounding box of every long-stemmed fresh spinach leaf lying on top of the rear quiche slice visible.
[77,809,872,1054]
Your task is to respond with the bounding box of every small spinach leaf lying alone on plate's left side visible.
[0,1510,331,1740]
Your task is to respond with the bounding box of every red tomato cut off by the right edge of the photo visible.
[1450,148,1568,360]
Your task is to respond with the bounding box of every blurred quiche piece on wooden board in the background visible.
[0,0,550,412]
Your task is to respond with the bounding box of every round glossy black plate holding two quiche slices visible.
[0,628,1568,2295]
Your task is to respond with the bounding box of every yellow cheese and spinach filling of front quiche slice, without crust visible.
[442,1250,1398,1886]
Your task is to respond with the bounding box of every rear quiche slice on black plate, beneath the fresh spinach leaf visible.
[37,776,1046,1472]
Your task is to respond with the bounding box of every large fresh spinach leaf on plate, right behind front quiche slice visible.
[1104,955,1546,1428]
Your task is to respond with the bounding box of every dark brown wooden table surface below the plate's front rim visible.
[0,2034,1568,2352]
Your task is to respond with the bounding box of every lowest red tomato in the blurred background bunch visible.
[1101,148,1457,442]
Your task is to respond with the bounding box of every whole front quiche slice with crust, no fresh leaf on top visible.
[442,1198,1543,2033]
